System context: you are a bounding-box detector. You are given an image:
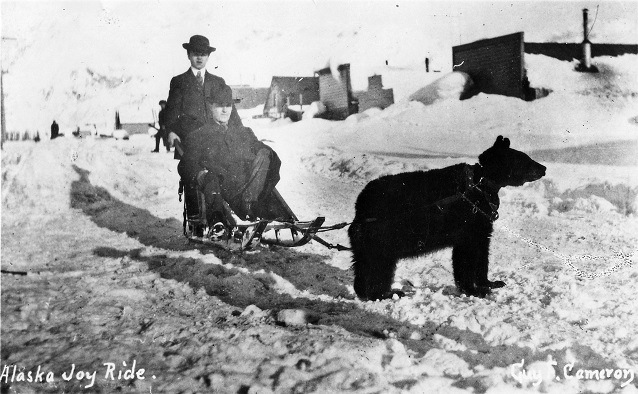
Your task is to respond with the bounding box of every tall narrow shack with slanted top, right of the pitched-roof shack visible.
[315,64,359,120]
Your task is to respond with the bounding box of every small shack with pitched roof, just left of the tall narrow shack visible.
[264,77,319,118]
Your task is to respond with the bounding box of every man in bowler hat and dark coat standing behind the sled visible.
[166,35,242,158]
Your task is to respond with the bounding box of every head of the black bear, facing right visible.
[479,135,546,187]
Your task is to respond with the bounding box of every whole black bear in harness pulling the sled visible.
[348,136,546,300]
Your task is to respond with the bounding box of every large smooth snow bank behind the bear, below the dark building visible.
[324,55,638,159]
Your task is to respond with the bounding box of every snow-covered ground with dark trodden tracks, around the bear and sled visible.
[0,50,638,393]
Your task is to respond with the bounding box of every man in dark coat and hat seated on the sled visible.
[178,86,281,234]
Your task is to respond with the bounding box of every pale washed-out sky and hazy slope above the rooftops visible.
[2,0,638,85]
